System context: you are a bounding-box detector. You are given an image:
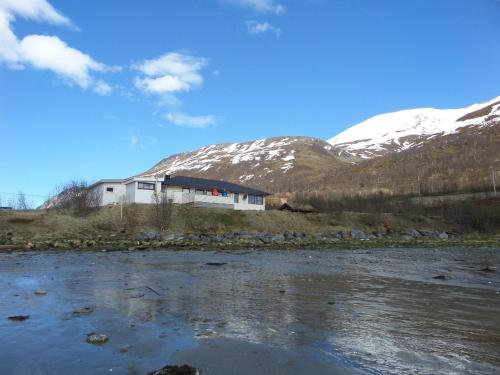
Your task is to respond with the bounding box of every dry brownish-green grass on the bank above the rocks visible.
[0,205,441,244]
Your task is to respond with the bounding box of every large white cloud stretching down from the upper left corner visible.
[0,0,115,94]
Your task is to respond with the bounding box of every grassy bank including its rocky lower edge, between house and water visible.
[0,205,500,250]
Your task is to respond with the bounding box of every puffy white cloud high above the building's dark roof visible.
[133,52,207,95]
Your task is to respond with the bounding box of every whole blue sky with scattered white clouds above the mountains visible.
[0,0,500,204]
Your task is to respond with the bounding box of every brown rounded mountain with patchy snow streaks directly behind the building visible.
[138,137,345,192]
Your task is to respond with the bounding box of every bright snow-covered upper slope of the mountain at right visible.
[328,97,500,161]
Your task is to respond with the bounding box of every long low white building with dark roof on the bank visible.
[91,175,269,210]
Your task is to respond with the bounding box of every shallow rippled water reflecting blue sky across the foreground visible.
[0,249,500,375]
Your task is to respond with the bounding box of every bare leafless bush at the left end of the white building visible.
[50,180,99,216]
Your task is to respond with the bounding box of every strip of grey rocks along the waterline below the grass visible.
[0,229,468,250]
